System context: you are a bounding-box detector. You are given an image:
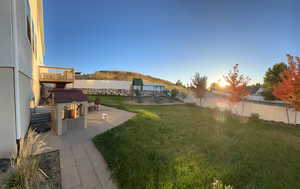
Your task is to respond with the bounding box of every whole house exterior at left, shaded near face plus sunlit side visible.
[0,0,45,157]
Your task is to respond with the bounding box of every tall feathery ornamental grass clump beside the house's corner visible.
[1,129,47,189]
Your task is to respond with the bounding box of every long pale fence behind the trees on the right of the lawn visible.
[182,94,300,124]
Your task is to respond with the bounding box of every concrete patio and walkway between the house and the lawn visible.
[41,106,135,189]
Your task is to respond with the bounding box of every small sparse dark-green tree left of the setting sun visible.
[191,73,207,105]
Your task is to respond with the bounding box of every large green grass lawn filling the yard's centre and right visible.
[93,97,300,189]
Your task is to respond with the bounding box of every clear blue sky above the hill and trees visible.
[44,0,300,82]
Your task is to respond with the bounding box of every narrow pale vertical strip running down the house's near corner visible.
[11,0,21,140]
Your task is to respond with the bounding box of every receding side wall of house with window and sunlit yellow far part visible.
[12,0,44,139]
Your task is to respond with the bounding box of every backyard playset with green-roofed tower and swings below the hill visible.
[130,78,170,103]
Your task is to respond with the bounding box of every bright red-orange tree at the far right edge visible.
[273,54,300,124]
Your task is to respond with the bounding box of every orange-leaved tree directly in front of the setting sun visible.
[224,64,250,111]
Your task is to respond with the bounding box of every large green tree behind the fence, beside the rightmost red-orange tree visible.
[262,62,287,100]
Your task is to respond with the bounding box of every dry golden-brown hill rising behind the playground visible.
[76,71,183,89]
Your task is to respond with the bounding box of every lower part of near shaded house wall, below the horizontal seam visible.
[0,68,16,158]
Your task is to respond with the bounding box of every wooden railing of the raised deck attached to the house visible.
[39,66,75,83]
